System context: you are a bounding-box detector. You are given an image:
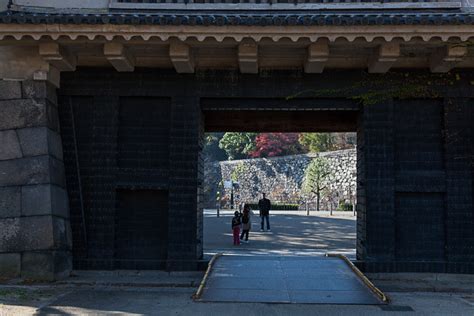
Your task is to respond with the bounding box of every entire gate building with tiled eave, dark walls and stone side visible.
[0,1,474,279]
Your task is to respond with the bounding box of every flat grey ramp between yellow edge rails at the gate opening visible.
[199,256,384,305]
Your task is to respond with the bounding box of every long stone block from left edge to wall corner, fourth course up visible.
[0,156,65,187]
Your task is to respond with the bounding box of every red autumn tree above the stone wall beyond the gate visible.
[249,133,304,158]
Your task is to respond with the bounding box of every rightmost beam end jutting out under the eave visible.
[430,46,467,73]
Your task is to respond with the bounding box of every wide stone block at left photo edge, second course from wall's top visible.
[0,99,48,130]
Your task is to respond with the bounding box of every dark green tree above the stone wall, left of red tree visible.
[219,132,257,160]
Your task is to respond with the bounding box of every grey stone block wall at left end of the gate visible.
[0,80,71,280]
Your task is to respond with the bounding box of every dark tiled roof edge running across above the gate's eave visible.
[0,10,474,26]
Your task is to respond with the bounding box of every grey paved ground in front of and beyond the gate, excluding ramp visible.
[0,210,474,316]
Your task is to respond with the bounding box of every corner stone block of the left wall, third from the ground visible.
[21,184,69,218]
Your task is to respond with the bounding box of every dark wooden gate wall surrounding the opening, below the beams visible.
[59,69,474,273]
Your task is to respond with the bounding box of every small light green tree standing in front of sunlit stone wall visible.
[302,157,331,211]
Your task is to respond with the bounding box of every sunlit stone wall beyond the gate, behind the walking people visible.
[204,149,357,209]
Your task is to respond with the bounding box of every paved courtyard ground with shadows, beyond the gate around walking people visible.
[204,210,356,259]
